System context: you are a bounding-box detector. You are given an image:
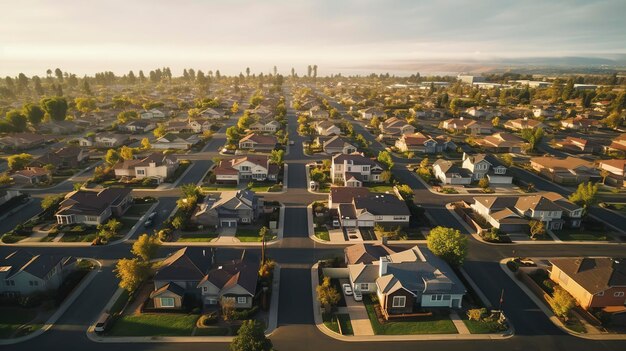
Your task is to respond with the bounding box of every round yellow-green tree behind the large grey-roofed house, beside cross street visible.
[427,227,467,266]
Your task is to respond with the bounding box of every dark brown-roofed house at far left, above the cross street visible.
[55,188,133,225]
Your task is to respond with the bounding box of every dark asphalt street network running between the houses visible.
[0,86,626,351]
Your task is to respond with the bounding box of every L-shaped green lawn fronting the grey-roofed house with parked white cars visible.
[363,297,457,335]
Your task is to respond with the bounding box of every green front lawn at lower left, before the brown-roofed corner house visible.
[109,313,199,336]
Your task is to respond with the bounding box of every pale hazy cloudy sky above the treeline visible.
[0,0,626,76]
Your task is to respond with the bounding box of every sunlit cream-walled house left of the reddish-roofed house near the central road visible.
[114,152,179,183]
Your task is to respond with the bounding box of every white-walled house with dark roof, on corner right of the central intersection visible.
[337,193,411,228]
